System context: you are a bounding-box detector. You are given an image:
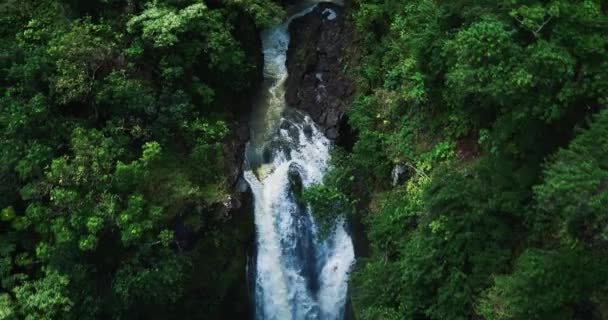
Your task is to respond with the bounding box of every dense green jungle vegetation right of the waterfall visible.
[328,0,608,320]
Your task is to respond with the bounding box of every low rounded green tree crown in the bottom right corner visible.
[479,249,607,319]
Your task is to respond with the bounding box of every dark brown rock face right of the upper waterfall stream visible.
[285,3,354,140]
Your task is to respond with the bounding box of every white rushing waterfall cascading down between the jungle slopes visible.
[244,3,355,320]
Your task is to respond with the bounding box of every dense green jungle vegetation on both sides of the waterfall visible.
[0,0,608,320]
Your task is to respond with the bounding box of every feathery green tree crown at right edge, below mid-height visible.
[530,110,608,246]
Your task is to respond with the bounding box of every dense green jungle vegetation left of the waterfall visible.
[0,0,284,320]
